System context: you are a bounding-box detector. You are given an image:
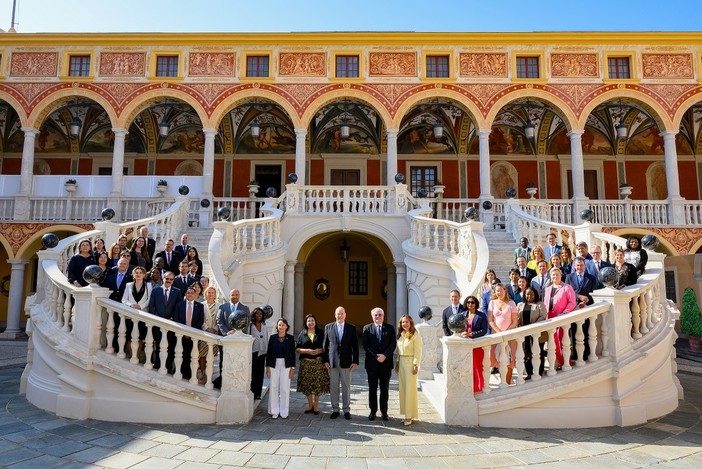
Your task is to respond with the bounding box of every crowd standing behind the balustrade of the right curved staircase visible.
[442,233,648,392]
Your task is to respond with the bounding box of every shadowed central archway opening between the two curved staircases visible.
[295,232,395,331]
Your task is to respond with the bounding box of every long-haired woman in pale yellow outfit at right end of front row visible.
[395,314,422,425]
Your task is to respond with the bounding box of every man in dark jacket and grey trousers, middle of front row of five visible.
[322,306,358,420]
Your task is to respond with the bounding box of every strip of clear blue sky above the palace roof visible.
[0,0,702,33]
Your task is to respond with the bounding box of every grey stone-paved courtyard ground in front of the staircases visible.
[0,336,702,469]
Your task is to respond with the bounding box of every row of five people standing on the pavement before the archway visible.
[262,306,422,425]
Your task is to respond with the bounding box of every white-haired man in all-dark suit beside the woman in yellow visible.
[363,308,397,420]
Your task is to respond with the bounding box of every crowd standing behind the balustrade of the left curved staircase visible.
[66,226,219,384]
